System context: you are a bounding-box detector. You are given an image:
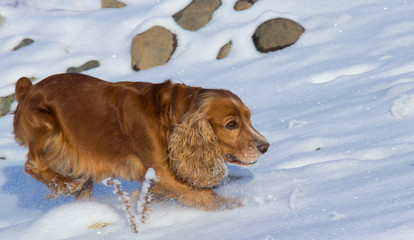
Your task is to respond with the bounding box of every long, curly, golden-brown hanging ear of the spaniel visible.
[168,109,227,188]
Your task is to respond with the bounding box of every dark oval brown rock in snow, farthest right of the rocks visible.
[252,18,305,53]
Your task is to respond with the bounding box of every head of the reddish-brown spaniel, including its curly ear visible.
[168,90,269,187]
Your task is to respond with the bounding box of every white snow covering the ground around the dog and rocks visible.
[0,0,414,240]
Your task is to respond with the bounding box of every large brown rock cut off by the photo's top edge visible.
[173,0,221,31]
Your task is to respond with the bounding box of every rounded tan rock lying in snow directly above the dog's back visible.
[131,26,177,71]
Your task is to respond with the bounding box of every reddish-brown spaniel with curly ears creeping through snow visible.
[13,73,270,210]
